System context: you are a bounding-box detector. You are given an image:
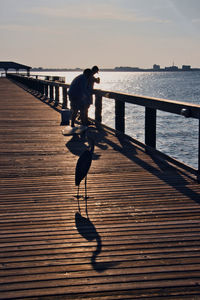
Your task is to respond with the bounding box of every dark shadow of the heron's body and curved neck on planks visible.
[75,212,118,273]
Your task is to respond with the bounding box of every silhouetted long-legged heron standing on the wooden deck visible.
[75,138,94,213]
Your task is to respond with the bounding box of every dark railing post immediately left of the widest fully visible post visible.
[115,100,125,133]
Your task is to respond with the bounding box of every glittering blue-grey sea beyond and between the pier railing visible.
[30,71,200,168]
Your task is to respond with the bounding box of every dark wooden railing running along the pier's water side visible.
[7,74,200,181]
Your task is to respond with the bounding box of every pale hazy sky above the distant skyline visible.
[0,0,200,68]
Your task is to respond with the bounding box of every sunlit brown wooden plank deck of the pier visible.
[0,78,200,299]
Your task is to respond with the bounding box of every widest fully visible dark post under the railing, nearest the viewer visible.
[145,107,156,149]
